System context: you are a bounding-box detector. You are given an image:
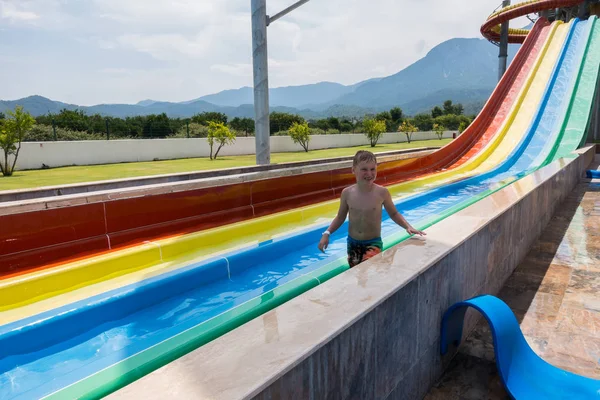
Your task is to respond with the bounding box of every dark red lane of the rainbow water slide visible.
[0,19,551,278]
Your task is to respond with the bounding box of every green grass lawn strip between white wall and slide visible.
[0,139,452,190]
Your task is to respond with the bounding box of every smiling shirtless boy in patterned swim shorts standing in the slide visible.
[319,150,425,268]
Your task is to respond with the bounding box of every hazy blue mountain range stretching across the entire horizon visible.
[0,39,518,119]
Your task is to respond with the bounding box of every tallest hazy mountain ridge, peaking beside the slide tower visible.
[185,38,518,113]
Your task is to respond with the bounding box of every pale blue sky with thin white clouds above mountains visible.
[0,0,527,105]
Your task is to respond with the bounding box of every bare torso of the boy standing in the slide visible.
[346,185,386,240]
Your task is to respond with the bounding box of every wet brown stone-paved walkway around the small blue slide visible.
[425,174,600,400]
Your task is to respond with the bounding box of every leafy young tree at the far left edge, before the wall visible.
[0,106,35,176]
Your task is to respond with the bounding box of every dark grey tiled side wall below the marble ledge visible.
[248,152,593,400]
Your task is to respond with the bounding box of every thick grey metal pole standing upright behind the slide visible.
[251,0,271,165]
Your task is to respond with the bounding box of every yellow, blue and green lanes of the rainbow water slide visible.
[0,6,600,399]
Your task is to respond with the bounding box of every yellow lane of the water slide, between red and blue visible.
[0,19,567,324]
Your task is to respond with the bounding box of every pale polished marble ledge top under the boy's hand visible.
[108,147,596,400]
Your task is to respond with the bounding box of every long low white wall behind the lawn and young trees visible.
[11,131,453,170]
